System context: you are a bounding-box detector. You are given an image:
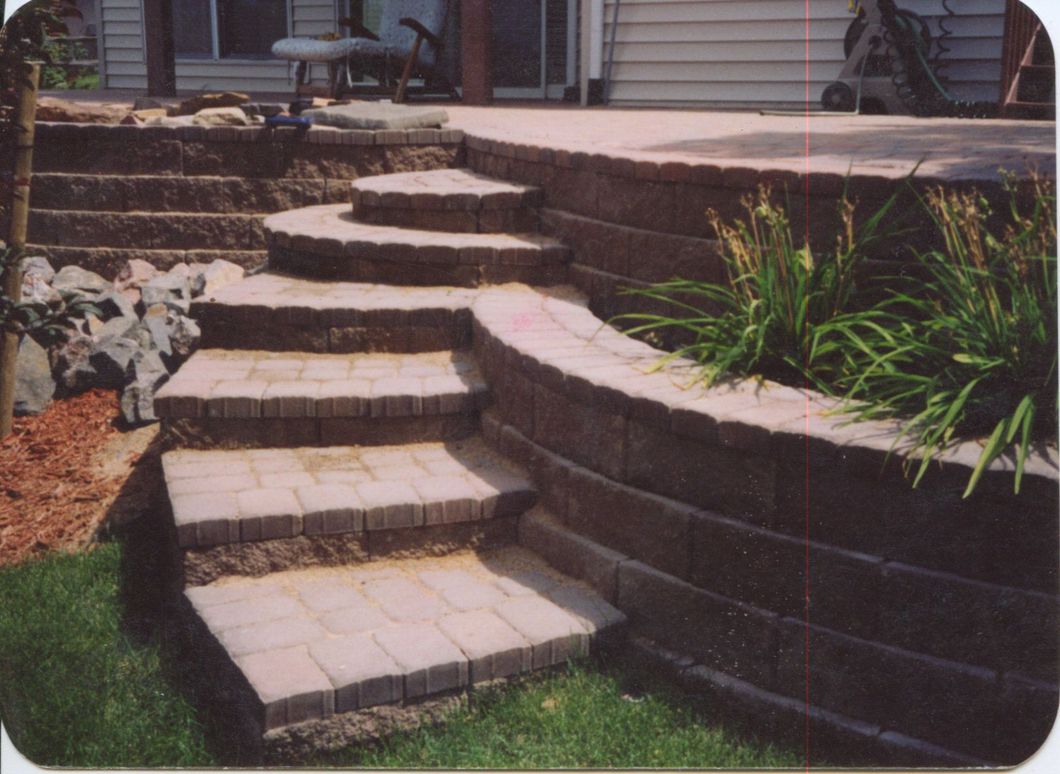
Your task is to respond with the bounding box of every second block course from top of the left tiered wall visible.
[32,172,339,214]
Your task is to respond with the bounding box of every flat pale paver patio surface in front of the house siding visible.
[446,105,1056,179]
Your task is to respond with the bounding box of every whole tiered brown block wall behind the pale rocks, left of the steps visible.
[15,122,463,277]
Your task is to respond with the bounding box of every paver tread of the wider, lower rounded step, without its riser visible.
[265,205,569,265]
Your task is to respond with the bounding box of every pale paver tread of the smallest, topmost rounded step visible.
[351,169,542,211]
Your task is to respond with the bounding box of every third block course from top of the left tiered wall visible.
[29,208,265,250]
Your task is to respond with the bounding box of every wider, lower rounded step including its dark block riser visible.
[265,205,570,287]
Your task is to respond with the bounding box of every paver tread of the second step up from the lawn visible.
[162,437,536,548]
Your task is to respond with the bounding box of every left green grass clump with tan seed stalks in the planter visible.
[615,188,897,392]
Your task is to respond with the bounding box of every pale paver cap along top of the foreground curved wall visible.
[472,287,1060,482]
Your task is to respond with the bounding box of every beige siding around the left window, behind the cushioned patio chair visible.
[101,0,346,92]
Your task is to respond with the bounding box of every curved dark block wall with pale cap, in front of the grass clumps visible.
[473,282,1058,764]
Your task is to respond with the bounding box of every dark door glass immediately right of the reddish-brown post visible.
[493,0,544,89]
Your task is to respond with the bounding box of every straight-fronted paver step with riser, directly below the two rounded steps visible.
[192,272,474,353]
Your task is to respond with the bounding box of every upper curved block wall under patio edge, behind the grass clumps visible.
[465,135,1032,318]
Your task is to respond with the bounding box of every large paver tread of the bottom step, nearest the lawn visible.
[184,547,625,732]
